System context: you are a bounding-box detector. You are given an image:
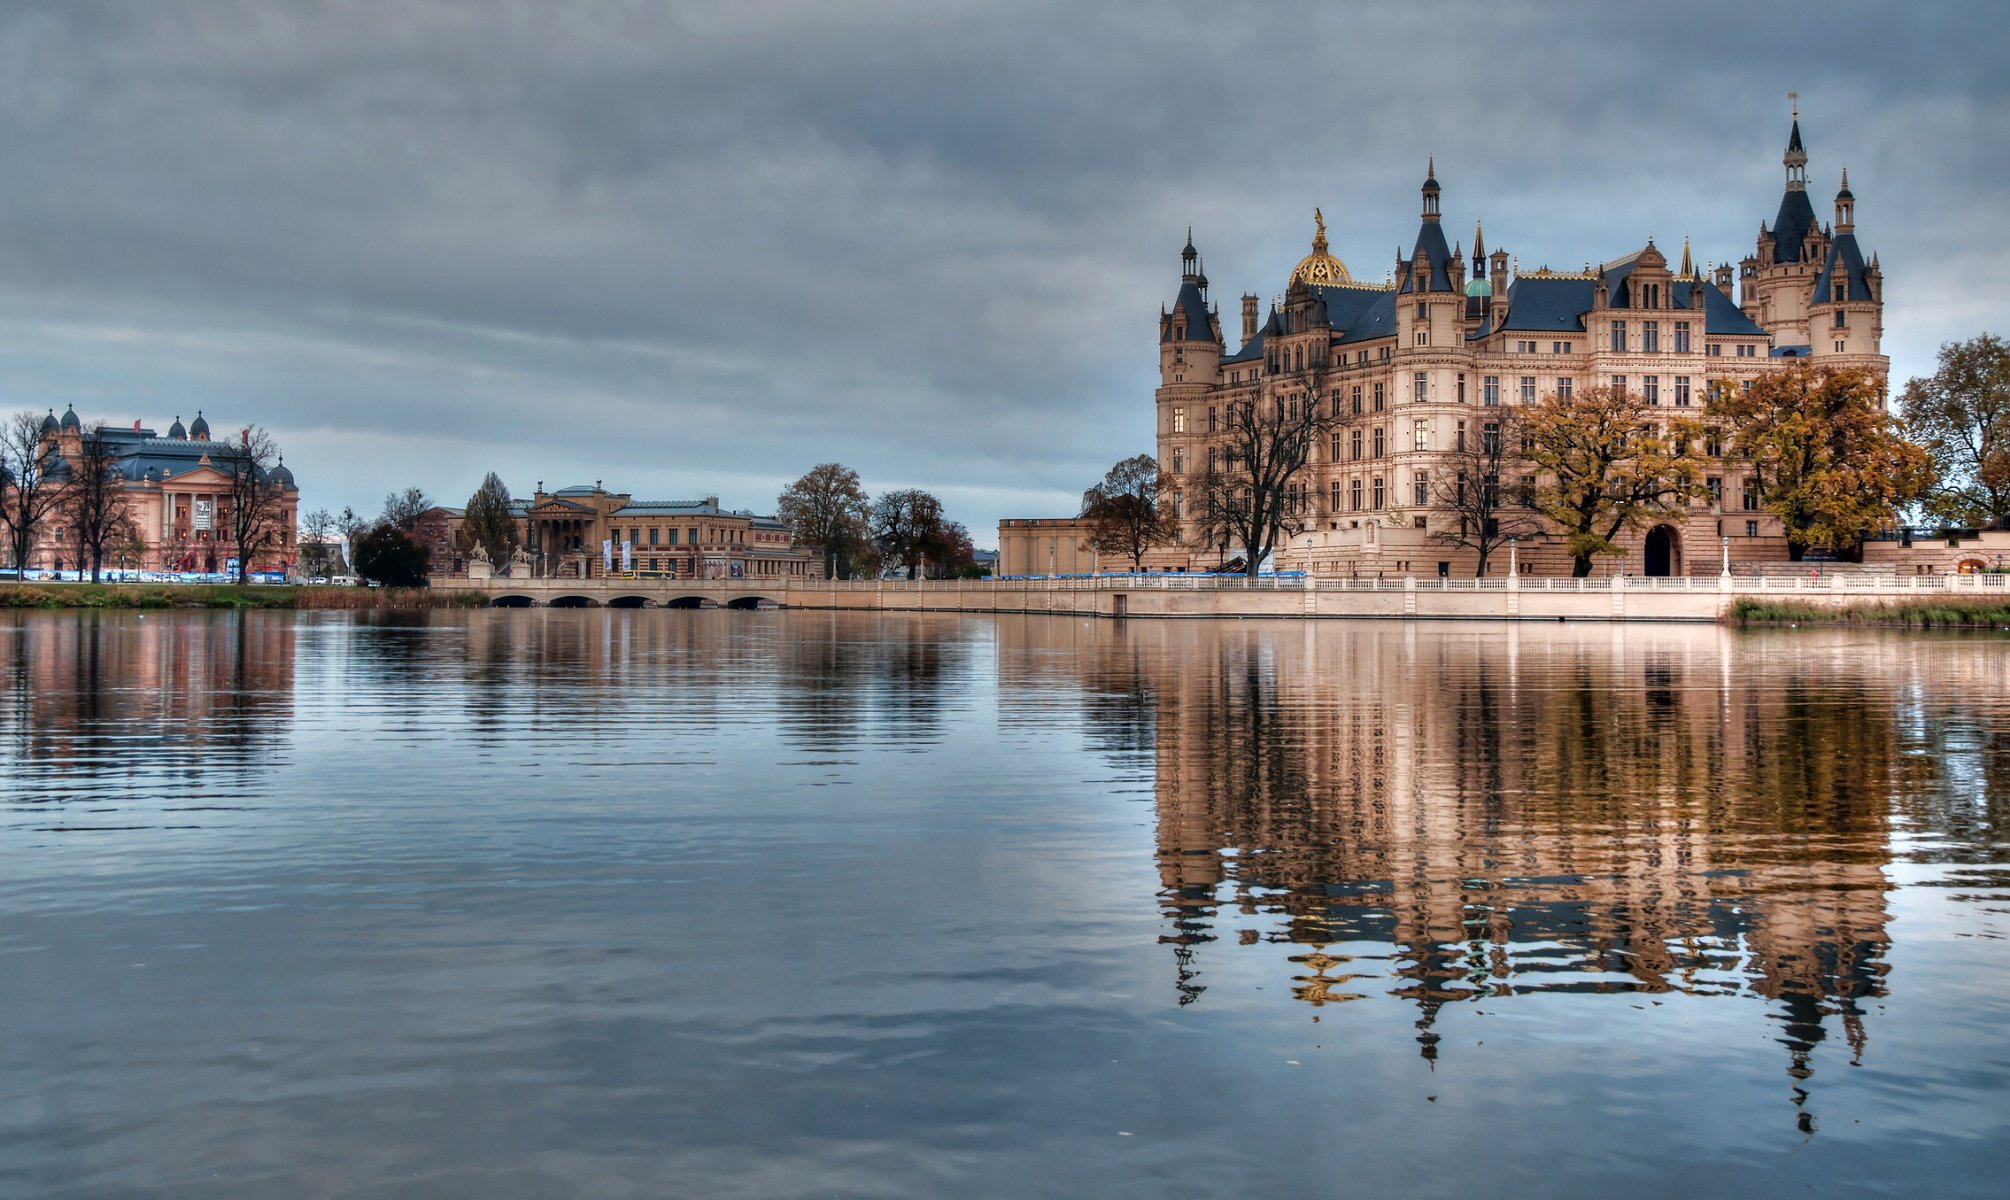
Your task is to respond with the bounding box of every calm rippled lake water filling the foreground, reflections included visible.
[0,609,2010,1198]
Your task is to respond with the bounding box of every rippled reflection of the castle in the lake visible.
[1001,621,2010,1117]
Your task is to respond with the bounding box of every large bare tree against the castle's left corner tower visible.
[1198,370,1343,577]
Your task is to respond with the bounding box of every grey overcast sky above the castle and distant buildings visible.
[0,0,2010,545]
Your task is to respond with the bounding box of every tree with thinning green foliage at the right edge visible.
[1899,334,2010,525]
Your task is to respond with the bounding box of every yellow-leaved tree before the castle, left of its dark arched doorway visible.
[1519,388,1702,579]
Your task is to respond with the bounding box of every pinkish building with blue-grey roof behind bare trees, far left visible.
[24,408,299,573]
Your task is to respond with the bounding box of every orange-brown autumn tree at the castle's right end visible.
[1709,362,1934,563]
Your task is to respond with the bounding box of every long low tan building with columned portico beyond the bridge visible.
[523,482,822,579]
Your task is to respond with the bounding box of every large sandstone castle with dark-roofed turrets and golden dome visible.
[1149,111,1889,575]
